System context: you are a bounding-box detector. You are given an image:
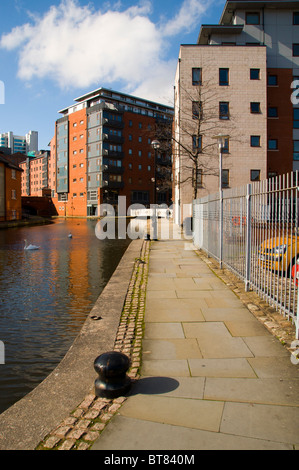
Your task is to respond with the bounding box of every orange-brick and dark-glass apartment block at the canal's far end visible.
[52,88,173,216]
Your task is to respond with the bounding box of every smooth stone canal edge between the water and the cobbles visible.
[0,240,143,450]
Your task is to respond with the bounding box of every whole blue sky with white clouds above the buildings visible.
[0,0,225,150]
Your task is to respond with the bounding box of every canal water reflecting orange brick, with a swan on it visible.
[0,219,130,413]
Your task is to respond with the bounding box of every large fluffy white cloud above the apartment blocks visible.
[0,0,211,101]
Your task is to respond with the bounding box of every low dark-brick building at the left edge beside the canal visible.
[0,153,22,222]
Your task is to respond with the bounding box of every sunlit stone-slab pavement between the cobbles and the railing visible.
[92,224,299,451]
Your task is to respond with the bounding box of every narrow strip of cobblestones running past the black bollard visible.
[36,240,150,450]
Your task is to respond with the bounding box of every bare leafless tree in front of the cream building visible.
[172,78,238,199]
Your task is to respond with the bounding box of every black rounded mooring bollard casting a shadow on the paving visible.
[94,351,131,398]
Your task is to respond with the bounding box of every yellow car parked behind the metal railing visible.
[259,236,299,276]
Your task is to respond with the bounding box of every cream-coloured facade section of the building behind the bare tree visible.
[173,45,267,223]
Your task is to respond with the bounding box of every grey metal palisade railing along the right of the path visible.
[193,172,299,339]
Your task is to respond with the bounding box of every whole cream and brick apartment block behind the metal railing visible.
[174,0,299,222]
